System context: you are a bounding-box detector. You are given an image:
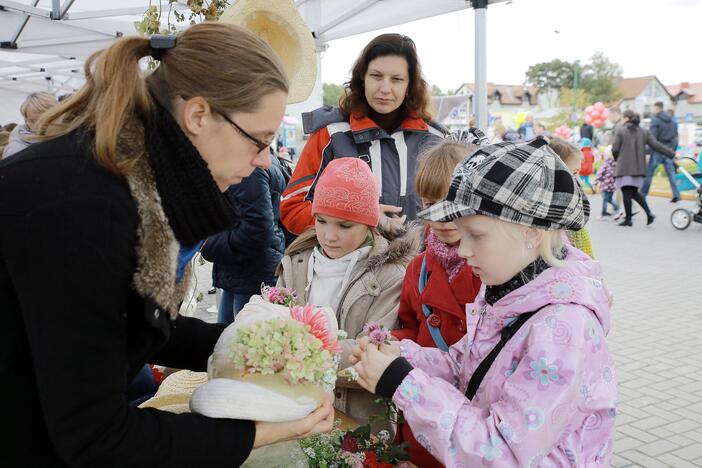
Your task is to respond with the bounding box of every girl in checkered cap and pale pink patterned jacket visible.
[353,137,617,467]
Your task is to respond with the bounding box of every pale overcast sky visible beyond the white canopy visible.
[322,0,702,91]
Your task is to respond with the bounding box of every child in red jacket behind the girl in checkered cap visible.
[392,140,481,468]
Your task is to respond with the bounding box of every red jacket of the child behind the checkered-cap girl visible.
[392,252,481,468]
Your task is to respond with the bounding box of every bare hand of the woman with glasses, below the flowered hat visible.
[253,395,334,448]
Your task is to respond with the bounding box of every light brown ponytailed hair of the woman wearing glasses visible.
[38,22,288,175]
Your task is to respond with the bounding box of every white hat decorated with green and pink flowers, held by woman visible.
[190,296,338,422]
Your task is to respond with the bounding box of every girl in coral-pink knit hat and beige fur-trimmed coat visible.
[278,158,419,431]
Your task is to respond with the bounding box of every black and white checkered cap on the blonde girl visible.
[419,137,590,230]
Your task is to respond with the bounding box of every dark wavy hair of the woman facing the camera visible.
[339,34,431,121]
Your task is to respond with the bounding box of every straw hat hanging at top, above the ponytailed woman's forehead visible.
[219,0,317,104]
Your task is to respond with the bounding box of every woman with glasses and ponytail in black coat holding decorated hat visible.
[0,23,333,467]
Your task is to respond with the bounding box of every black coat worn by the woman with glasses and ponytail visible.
[0,135,255,468]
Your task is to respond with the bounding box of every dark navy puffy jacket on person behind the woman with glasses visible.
[202,157,287,294]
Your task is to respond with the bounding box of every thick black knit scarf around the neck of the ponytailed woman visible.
[145,100,239,246]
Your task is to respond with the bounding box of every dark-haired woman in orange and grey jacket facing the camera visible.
[280,34,444,234]
